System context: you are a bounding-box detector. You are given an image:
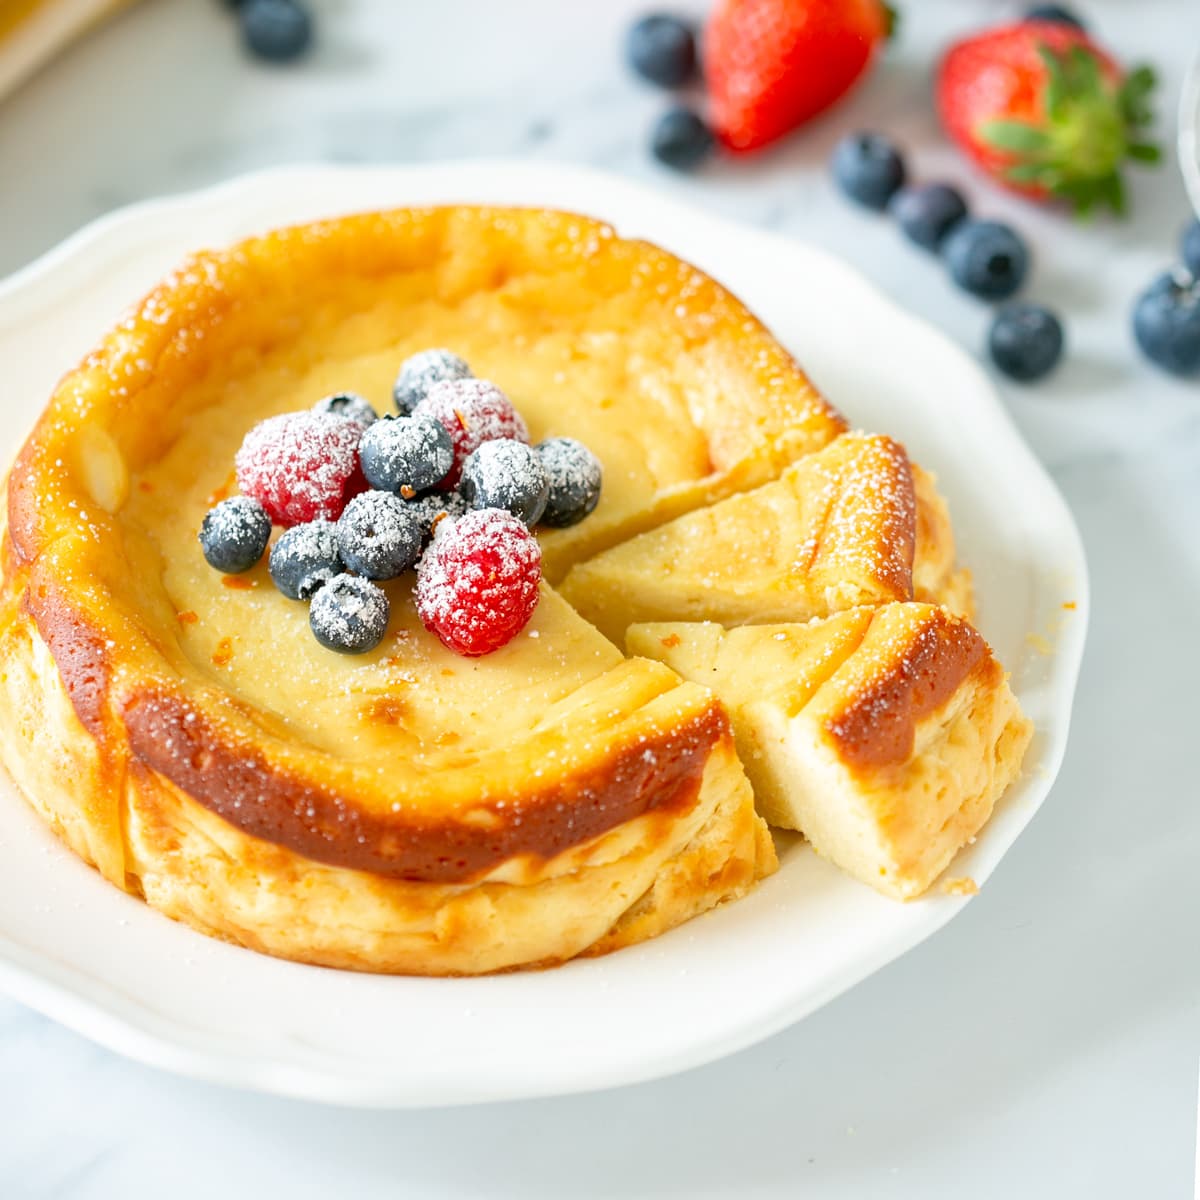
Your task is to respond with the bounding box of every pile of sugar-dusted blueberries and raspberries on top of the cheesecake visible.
[200,350,601,656]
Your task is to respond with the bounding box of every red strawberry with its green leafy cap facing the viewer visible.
[937,20,1159,212]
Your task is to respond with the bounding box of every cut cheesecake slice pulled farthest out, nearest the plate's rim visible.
[628,604,1032,900]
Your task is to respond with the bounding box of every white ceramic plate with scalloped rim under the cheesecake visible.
[0,163,1087,1106]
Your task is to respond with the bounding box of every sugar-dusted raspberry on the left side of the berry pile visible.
[235,412,367,526]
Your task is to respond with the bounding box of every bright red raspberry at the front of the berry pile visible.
[416,509,541,658]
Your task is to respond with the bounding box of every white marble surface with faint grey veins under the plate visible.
[0,0,1200,1200]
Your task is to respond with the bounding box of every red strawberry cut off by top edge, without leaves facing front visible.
[703,0,893,150]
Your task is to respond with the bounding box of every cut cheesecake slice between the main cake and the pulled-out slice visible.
[562,433,971,644]
